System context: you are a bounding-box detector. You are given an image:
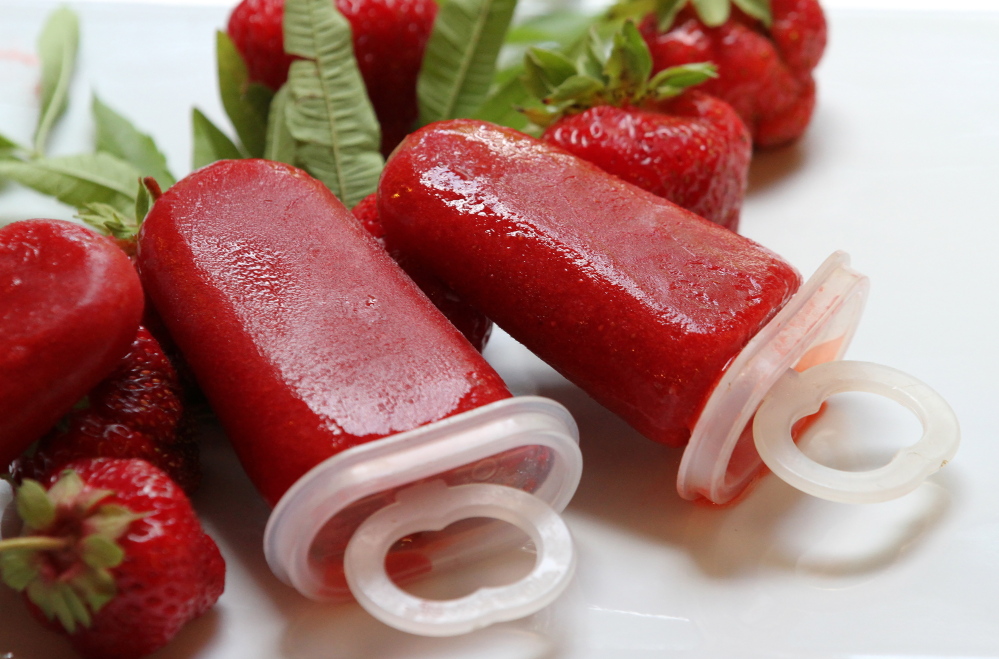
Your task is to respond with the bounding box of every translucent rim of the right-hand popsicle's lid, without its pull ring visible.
[677,252,870,504]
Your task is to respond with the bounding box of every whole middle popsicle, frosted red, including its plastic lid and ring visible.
[138,160,581,635]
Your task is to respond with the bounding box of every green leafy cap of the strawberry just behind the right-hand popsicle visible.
[521,20,718,128]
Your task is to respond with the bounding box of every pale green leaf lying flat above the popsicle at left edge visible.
[0,152,139,213]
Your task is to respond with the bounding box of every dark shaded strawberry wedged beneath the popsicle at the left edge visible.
[11,327,200,492]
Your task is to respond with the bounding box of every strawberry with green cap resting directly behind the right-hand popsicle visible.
[525,22,752,231]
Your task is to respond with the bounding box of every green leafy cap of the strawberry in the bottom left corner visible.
[0,470,145,634]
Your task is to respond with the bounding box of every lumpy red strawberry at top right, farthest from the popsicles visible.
[642,0,826,147]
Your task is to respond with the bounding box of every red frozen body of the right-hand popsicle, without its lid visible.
[379,120,801,445]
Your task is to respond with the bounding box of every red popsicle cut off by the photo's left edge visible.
[0,220,143,469]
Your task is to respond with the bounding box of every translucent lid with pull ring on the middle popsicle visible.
[264,396,582,636]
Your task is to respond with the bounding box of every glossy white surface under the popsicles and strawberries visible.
[0,0,999,659]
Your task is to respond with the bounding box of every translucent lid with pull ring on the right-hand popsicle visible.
[677,252,959,503]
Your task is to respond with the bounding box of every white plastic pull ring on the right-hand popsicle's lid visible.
[753,361,960,503]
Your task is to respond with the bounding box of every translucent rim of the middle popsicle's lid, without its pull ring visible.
[264,396,582,635]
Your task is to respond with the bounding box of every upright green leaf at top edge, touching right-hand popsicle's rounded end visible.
[416,0,517,125]
